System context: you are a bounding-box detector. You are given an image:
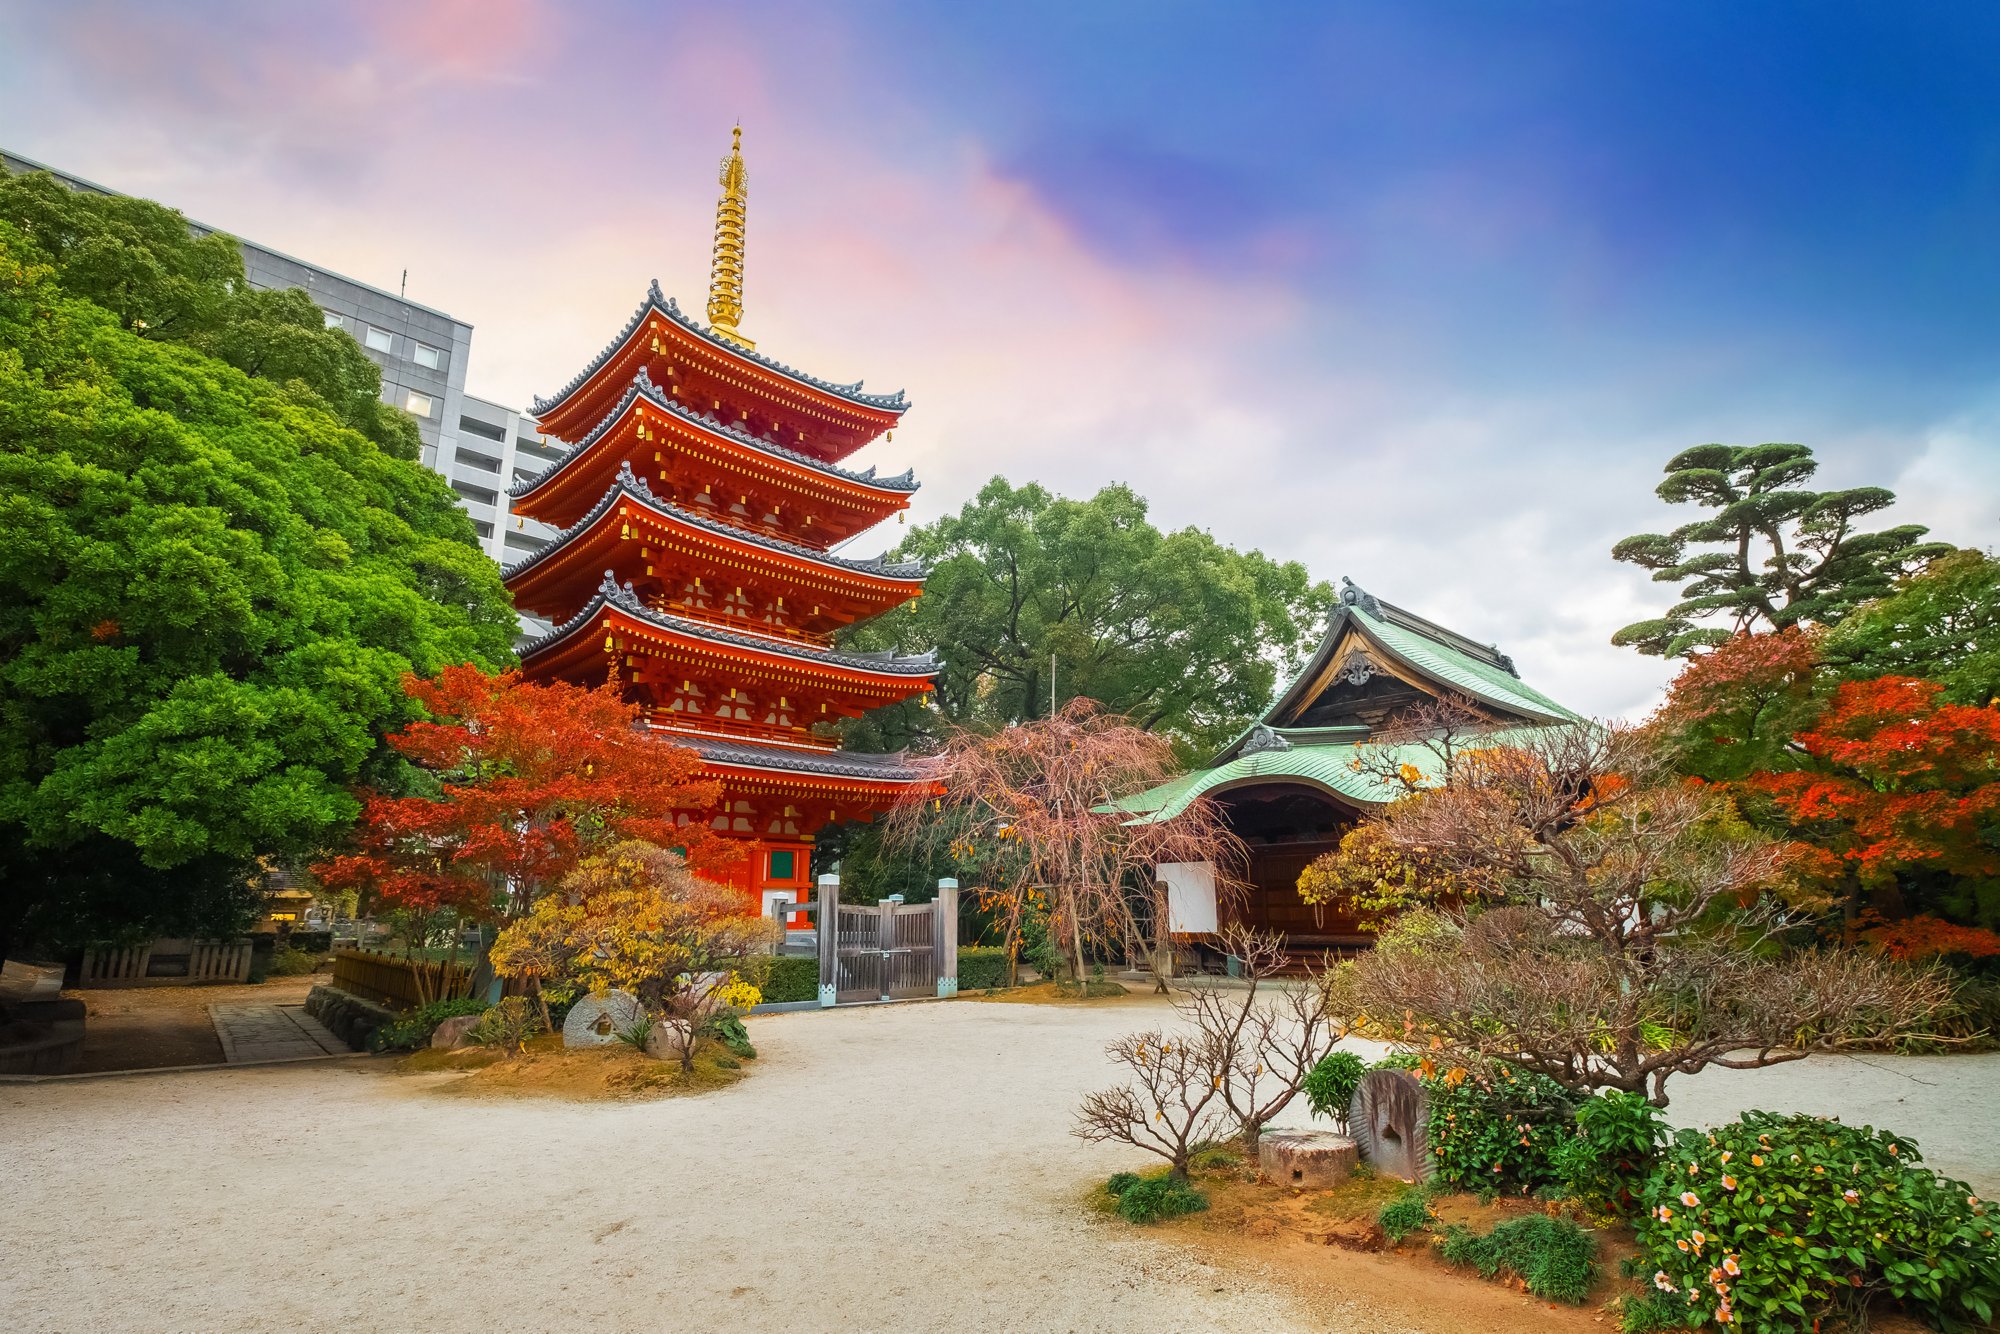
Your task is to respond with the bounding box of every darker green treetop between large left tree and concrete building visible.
[0,172,420,458]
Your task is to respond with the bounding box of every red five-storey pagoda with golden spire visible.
[504,128,938,910]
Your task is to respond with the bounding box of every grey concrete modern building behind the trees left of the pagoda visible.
[0,150,562,568]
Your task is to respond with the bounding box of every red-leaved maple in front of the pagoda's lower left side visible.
[314,666,740,916]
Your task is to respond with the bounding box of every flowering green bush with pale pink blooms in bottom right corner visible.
[1638,1112,2000,1330]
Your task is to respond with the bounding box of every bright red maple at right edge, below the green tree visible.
[1750,676,2000,928]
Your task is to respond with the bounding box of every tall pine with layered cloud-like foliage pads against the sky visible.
[1612,444,1952,658]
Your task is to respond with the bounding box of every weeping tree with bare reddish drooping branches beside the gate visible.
[886,700,1246,980]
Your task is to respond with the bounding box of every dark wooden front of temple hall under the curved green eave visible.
[1216,782,1370,948]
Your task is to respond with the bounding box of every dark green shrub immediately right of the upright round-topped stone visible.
[1420,1064,1574,1194]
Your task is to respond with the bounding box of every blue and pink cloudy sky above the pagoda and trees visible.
[0,0,2000,718]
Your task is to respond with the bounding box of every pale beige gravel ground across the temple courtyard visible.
[0,998,2000,1334]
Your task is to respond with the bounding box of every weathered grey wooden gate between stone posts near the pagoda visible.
[818,882,958,1006]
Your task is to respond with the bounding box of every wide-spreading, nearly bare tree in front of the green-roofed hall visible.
[1334,724,1948,1106]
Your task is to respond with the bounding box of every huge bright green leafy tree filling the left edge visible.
[0,214,514,948]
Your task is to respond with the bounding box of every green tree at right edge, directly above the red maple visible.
[1820,550,2000,708]
